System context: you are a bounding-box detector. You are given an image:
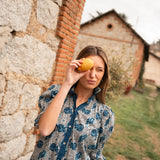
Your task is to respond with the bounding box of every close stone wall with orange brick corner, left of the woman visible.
[0,0,85,160]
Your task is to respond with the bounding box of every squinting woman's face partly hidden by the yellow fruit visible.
[78,55,105,89]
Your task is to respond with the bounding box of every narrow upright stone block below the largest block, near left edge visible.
[2,80,23,115]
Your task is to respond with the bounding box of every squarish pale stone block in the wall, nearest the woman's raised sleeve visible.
[20,84,41,110]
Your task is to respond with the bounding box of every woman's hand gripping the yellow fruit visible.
[65,60,87,86]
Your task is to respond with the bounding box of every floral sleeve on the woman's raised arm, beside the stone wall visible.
[34,85,60,128]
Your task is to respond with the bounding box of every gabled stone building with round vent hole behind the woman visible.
[75,10,149,85]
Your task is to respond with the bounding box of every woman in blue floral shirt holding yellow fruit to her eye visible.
[31,46,114,160]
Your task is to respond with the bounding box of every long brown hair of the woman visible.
[76,46,109,104]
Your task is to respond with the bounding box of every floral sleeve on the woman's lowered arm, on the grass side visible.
[91,107,115,160]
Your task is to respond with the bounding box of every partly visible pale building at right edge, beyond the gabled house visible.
[143,42,160,88]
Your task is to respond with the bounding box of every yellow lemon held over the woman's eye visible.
[78,58,94,71]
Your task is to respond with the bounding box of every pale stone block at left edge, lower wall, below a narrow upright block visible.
[0,111,25,142]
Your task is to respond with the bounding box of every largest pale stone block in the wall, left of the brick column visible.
[2,36,56,81]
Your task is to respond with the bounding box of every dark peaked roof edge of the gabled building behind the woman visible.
[81,9,149,61]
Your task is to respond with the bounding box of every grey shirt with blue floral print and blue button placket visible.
[30,85,114,160]
